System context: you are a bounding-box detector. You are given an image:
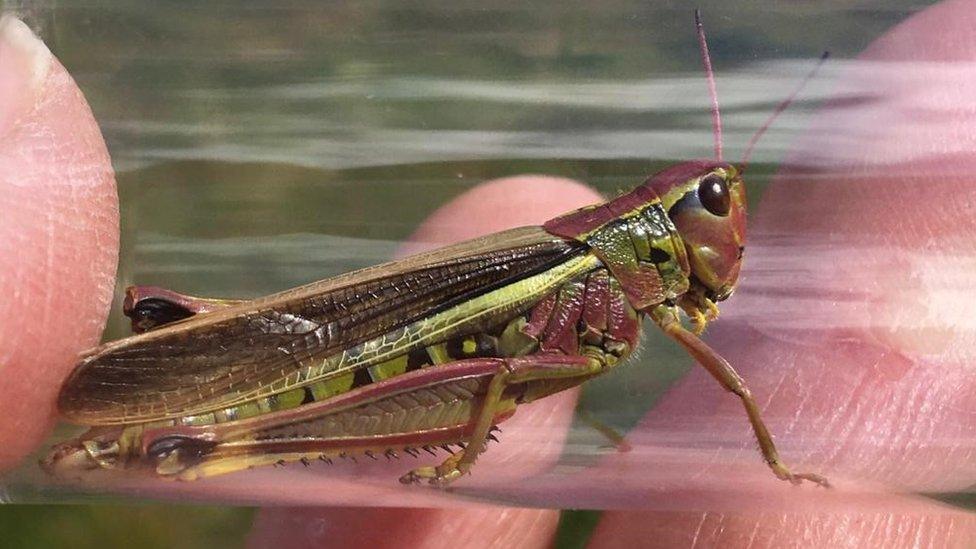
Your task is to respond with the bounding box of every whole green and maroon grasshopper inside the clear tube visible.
[42,10,827,486]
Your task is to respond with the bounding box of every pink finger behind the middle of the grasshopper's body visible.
[251,176,600,547]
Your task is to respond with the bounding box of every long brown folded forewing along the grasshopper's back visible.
[58,227,585,424]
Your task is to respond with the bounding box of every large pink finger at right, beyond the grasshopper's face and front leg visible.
[593,2,976,547]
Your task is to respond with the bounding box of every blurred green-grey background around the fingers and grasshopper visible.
[0,0,927,547]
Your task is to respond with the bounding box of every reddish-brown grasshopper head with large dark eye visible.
[644,161,746,302]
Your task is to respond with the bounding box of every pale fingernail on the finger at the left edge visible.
[0,15,52,136]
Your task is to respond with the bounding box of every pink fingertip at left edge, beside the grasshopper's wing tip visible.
[0,16,119,470]
